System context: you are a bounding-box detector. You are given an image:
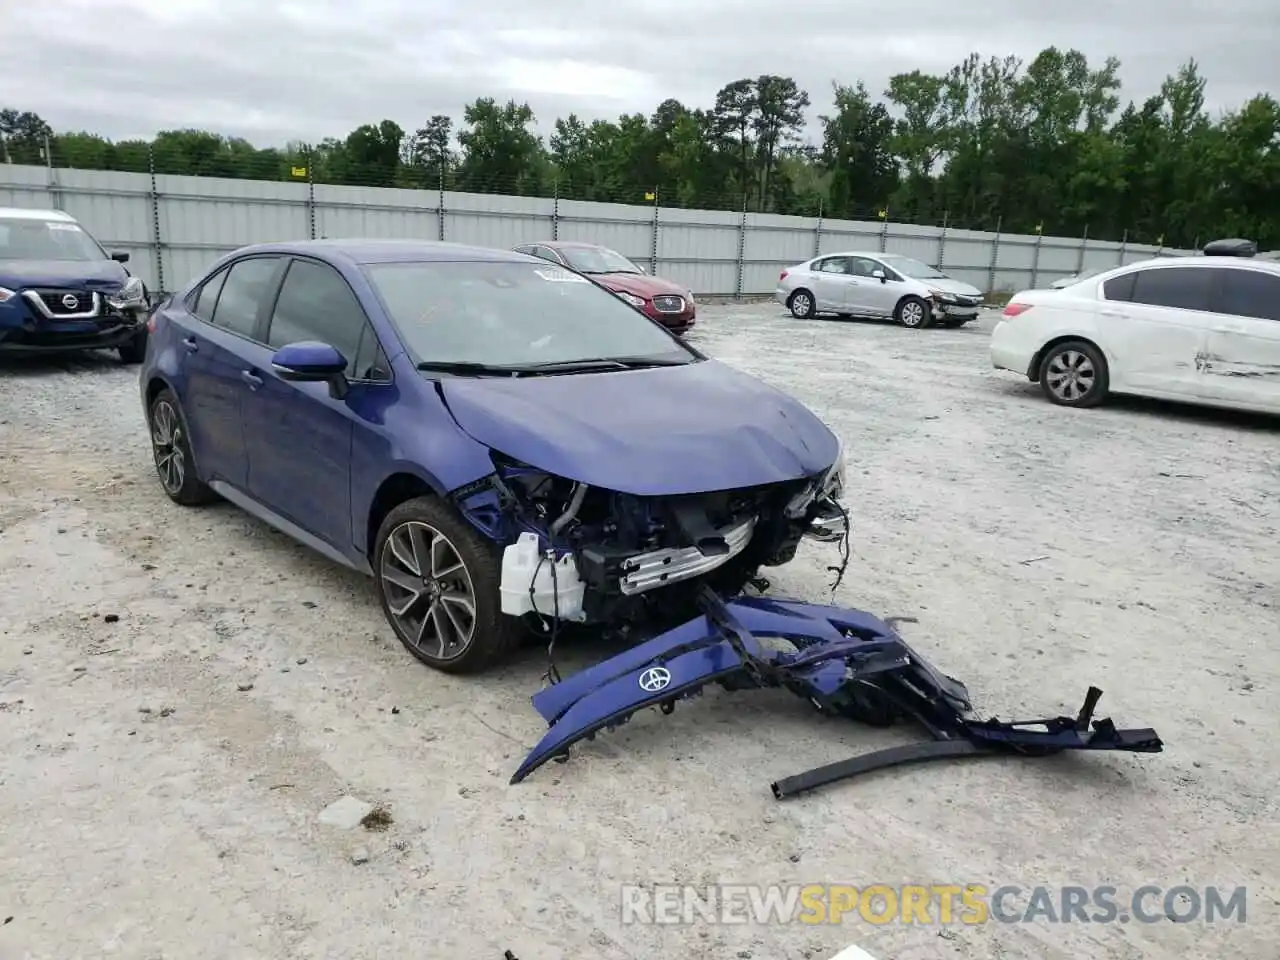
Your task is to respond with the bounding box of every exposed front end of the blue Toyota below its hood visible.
[454,449,849,634]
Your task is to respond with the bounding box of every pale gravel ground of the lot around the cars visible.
[0,305,1280,960]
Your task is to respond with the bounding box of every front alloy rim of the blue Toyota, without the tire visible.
[379,520,476,660]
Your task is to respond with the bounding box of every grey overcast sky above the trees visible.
[0,0,1280,146]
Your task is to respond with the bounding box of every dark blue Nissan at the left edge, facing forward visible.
[0,207,148,364]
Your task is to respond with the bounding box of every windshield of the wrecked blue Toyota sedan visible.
[365,261,698,367]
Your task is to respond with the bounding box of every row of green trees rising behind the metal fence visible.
[0,47,1280,248]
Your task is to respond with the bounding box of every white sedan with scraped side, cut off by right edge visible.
[991,244,1280,413]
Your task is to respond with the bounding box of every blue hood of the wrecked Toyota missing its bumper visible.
[440,360,840,497]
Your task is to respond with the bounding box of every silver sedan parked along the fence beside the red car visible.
[773,251,982,330]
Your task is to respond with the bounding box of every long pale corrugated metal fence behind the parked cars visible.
[0,164,1190,296]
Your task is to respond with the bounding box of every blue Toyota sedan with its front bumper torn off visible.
[140,239,847,672]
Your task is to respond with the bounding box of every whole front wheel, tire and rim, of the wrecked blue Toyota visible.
[374,497,524,673]
